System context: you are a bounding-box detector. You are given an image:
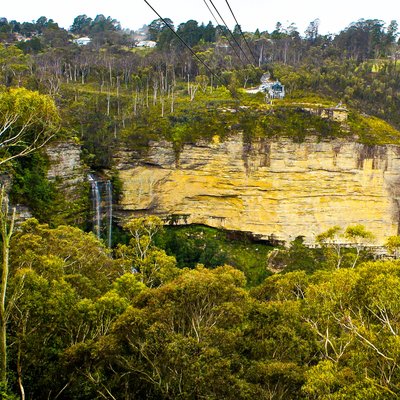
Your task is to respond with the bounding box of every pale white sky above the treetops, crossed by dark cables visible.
[0,0,400,34]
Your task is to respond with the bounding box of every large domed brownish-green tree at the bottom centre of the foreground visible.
[84,267,247,398]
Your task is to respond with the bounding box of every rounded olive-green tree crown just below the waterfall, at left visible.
[12,219,124,297]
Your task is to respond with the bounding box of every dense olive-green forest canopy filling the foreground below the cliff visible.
[3,212,400,400]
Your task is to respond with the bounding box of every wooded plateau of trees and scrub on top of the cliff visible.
[0,15,400,169]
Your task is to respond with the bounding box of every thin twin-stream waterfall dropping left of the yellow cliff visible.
[88,174,113,247]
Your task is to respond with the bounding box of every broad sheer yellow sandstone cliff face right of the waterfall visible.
[119,135,400,244]
